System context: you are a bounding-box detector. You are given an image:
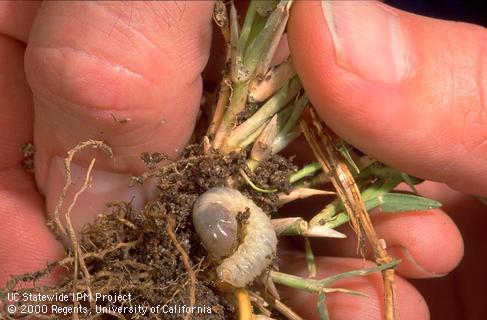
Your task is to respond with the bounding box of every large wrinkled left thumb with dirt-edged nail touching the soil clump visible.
[25,1,213,230]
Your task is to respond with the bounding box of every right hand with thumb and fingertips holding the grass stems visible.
[285,1,487,319]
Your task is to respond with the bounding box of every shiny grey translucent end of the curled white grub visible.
[193,188,238,258]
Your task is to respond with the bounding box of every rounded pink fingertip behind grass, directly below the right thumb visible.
[308,209,463,278]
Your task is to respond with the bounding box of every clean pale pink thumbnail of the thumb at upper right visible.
[322,0,409,83]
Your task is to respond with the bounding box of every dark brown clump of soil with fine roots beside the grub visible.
[0,145,296,319]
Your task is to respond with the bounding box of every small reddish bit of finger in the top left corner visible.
[0,1,41,43]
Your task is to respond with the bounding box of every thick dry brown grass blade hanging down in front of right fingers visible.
[301,109,395,320]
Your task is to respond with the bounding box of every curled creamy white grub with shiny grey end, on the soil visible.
[193,188,277,288]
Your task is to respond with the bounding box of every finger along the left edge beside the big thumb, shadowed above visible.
[0,35,63,287]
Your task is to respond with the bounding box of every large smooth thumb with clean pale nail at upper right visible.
[288,1,487,195]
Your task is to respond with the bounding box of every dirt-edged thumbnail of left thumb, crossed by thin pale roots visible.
[46,157,146,236]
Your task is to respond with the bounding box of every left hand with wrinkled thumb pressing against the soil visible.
[0,1,213,286]
